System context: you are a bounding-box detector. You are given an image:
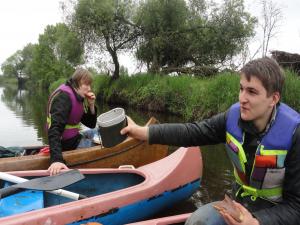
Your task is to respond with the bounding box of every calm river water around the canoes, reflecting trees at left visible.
[0,86,233,216]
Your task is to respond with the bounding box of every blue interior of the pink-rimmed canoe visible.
[0,173,145,217]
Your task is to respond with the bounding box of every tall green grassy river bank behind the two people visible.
[94,71,300,120]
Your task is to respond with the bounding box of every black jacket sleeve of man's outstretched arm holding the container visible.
[149,113,226,147]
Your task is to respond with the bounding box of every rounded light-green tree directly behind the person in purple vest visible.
[28,23,84,88]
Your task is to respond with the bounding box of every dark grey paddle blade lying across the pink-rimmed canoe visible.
[13,170,84,191]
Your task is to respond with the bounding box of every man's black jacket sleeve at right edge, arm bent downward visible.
[253,127,300,225]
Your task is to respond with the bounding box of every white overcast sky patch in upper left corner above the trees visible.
[0,0,62,67]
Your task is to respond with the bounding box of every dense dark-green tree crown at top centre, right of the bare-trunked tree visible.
[135,0,189,72]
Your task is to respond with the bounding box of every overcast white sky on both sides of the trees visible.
[0,0,300,74]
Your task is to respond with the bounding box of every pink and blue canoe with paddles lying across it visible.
[0,147,202,225]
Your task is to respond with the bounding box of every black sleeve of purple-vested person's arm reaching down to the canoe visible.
[48,92,72,163]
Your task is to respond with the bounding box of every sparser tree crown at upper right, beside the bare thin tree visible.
[189,0,256,66]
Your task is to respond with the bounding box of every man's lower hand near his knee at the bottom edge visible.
[219,201,259,225]
